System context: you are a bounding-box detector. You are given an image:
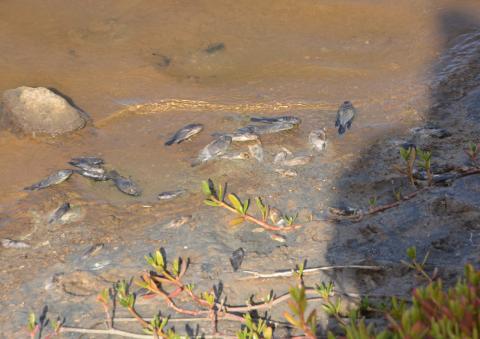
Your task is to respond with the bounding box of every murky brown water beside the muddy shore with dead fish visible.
[0,0,480,211]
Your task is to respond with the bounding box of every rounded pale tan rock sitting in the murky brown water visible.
[0,86,86,135]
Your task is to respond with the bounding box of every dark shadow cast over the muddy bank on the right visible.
[325,10,480,334]
